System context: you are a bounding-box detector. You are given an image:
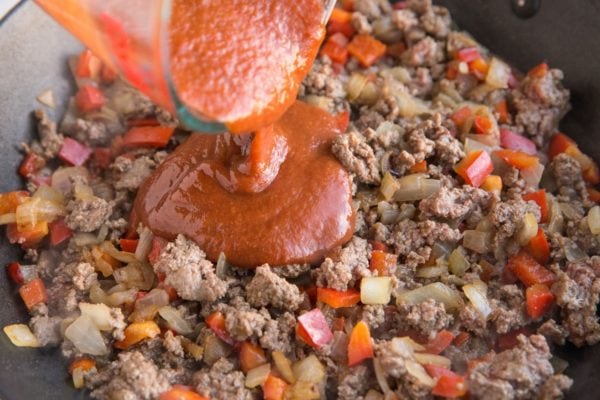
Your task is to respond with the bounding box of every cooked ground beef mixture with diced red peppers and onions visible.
[0,0,600,400]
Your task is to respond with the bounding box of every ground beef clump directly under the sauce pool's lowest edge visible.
[246,264,304,311]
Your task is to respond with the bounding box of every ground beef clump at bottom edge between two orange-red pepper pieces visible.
[193,358,253,400]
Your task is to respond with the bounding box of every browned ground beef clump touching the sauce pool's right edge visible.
[331,131,381,184]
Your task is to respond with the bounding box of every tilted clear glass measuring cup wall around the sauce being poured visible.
[35,0,335,132]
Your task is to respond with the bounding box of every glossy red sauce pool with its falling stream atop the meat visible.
[132,102,355,267]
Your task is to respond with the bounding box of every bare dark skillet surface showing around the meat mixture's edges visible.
[0,0,600,400]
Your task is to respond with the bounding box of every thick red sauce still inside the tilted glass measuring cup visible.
[169,0,324,133]
